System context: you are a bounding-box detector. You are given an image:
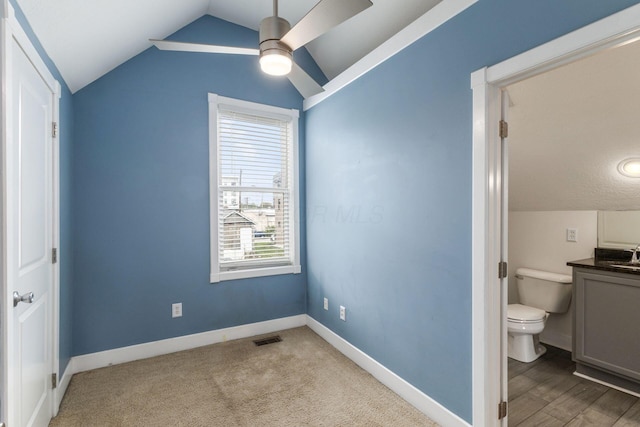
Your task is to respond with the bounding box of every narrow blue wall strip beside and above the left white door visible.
[9,0,73,374]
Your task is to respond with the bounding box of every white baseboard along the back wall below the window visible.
[71,314,307,374]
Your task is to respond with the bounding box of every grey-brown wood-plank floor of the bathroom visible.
[509,346,640,427]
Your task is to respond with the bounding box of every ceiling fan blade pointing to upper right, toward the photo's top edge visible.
[280,0,373,50]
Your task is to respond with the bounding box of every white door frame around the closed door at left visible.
[0,0,62,425]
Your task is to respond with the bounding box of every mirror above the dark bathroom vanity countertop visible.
[598,211,640,249]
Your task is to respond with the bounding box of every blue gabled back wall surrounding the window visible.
[73,16,319,355]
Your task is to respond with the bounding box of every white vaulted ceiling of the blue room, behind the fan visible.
[17,0,441,92]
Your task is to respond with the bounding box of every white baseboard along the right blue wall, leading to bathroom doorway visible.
[307,316,470,427]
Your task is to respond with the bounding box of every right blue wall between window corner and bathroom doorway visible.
[306,0,637,422]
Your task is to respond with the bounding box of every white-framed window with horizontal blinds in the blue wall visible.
[209,94,300,283]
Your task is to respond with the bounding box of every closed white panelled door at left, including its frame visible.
[0,2,60,427]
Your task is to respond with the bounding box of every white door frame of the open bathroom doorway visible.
[471,5,640,426]
